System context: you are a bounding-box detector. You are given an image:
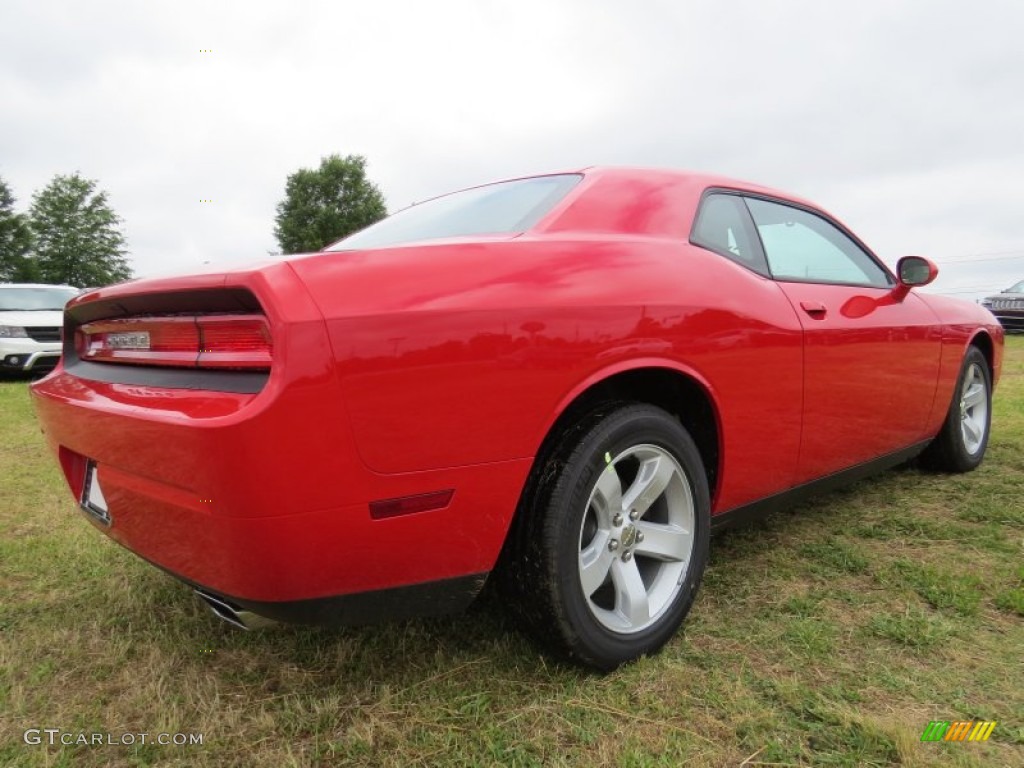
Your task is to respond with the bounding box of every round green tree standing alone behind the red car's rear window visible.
[273,155,387,253]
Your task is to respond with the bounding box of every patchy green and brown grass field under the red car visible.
[0,337,1024,768]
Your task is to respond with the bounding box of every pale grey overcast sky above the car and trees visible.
[0,0,1024,298]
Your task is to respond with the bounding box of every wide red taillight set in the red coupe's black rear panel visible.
[75,314,273,371]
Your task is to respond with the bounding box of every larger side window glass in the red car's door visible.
[746,198,891,288]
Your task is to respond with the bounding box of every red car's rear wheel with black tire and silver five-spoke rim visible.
[505,404,711,671]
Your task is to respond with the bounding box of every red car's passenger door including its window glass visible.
[745,198,941,482]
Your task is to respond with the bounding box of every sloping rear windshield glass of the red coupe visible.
[325,173,583,251]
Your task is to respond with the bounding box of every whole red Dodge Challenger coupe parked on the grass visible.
[32,169,1004,669]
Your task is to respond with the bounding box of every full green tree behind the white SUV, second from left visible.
[29,173,131,288]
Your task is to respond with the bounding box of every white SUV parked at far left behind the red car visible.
[0,283,81,372]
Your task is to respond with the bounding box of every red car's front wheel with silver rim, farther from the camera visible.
[921,346,992,472]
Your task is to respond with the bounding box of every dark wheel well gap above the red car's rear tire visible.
[538,368,720,501]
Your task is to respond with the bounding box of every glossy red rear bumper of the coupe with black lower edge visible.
[33,368,530,624]
